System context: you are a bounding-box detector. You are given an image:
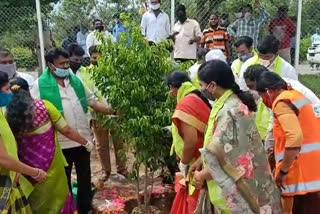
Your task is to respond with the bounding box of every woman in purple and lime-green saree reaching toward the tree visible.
[7,78,93,214]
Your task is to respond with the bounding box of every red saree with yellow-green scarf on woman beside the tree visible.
[171,82,210,214]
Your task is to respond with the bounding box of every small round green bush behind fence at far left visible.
[11,46,37,68]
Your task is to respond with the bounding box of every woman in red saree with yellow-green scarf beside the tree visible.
[168,71,211,214]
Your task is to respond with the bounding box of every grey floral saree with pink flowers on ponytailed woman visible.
[201,94,282,214]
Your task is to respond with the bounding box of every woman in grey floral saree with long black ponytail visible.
[194,60,282,214]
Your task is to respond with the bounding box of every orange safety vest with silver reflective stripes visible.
[272,90,320,196]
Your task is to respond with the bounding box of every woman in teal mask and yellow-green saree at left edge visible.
[0,71,47,214]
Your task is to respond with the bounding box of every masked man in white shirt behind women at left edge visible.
[0,50,34,88]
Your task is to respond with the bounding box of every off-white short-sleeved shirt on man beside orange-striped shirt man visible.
[172,19,202,59]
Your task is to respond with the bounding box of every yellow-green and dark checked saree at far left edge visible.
[0,109,33,214]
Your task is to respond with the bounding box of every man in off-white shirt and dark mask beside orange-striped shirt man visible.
[172,5,202,62]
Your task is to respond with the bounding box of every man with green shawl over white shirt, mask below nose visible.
[31,48,114,214]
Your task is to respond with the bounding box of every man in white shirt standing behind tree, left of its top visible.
[86,19,115,54]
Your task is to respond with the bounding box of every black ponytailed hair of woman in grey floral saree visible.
[198,60,257,111]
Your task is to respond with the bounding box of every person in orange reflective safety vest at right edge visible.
[256,72,320,214]
